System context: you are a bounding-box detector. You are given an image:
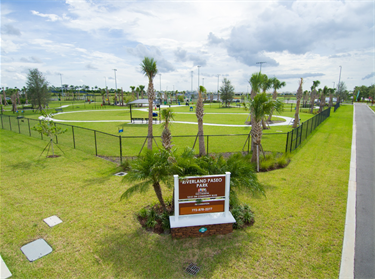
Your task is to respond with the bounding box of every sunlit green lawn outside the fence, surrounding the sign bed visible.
[0,106,352,278]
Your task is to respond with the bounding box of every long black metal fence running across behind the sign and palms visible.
[0,114,287,163]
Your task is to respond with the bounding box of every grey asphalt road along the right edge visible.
[354,104,375,279]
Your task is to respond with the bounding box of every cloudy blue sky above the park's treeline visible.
[1,0,375,92]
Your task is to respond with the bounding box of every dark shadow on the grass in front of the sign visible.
[97,228,259,279]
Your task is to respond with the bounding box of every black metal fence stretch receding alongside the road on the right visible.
[285,108,331,153]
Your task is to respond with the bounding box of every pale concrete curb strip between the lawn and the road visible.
[339,106,357,279]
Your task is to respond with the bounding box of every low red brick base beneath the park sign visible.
[171,223,233,241]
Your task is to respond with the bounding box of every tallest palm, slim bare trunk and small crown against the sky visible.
[141,57,158,150]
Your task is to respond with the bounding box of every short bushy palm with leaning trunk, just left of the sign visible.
[121,150,173,211]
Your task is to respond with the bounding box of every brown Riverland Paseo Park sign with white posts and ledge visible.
[169,172,235,237]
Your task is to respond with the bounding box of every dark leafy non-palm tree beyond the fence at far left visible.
[26,69,50,111]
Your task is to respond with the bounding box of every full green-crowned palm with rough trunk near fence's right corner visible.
[249,93,283,165]
